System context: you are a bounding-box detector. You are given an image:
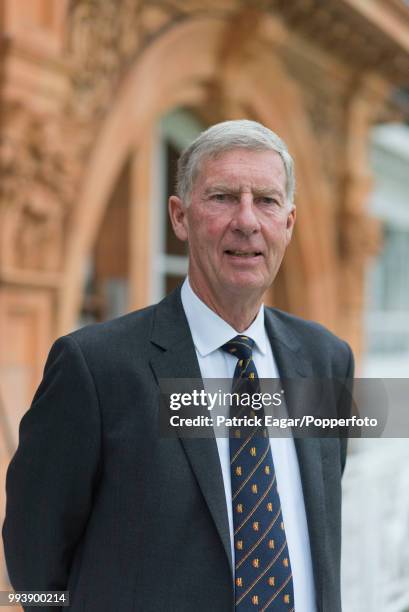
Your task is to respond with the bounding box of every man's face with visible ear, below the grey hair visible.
[169,149,295,303]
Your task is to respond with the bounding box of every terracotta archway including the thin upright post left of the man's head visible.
[57,18,336,334]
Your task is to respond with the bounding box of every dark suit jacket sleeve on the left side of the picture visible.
[3,336,101,596]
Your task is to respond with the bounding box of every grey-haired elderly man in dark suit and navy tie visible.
[3,120,353,612]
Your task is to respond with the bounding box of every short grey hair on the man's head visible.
[176,119,295,206]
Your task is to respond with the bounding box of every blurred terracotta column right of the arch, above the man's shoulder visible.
[338,76,388,357]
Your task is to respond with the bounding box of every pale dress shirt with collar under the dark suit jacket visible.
[181,278,316,612]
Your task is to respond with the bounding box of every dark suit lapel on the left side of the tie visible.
[151,290,232,568]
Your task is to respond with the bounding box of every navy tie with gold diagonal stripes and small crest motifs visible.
[221,335,294,612]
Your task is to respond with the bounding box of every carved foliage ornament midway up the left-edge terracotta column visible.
[0,102,78,271]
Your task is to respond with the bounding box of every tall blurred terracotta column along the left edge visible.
[0,0,75,444]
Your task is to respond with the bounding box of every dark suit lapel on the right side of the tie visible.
[265,308,326,610]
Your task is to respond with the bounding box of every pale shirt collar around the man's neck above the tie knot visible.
[181,277,267,357]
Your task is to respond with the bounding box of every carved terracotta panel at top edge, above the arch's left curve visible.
[67,0,258,119]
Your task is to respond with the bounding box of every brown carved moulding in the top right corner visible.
[268,0,409,86]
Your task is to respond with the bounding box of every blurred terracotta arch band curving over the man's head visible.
[57,18,335,333]
